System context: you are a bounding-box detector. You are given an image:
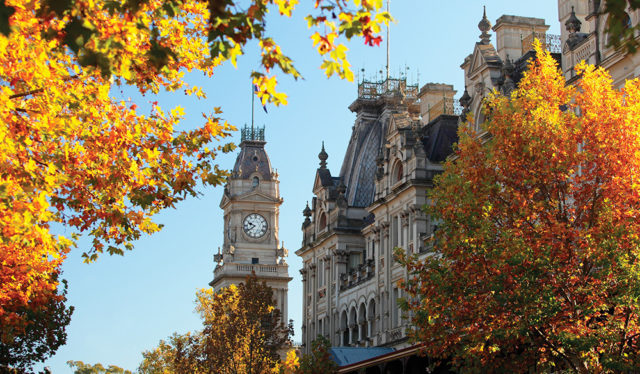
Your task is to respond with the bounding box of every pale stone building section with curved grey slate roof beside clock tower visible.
[296,78,458,349]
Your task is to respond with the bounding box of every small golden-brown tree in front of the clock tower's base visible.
[139,275,293,374]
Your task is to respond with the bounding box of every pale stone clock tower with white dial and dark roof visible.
[209,126,292,324]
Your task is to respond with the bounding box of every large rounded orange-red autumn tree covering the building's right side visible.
[403,45,640,373]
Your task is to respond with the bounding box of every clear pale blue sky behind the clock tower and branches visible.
[45,0,560,373]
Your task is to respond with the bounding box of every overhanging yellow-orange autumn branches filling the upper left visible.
[0,0,388,354]
